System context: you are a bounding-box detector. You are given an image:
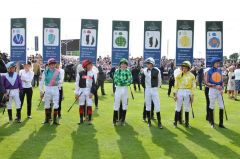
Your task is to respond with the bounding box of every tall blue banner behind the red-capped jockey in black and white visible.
[80,19,98,64]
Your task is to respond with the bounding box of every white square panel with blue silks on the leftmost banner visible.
[12,28,25,46]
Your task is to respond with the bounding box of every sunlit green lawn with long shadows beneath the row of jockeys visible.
[0,83,240,159]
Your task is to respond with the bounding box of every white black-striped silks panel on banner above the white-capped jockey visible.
[145,31,160,49]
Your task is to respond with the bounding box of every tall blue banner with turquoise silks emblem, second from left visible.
[43,18,61,63]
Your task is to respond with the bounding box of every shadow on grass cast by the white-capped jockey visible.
[150,127,197,159]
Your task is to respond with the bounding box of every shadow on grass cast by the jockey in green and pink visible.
[10,125,57,159]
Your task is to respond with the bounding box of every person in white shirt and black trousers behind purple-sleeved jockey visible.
[19,61,34,119]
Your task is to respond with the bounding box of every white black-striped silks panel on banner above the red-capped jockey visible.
[82,29,97,47]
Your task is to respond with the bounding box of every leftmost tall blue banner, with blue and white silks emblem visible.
[10,18,27,64]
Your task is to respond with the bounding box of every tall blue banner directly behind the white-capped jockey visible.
[143,21,162,68]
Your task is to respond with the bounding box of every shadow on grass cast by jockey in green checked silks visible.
[115,124,150,159]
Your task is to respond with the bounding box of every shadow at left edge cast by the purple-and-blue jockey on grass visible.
[0,119,28,143]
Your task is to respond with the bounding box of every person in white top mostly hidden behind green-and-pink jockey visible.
[56,64,65,118]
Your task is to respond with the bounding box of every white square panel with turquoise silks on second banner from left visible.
[44,28,59,46]
